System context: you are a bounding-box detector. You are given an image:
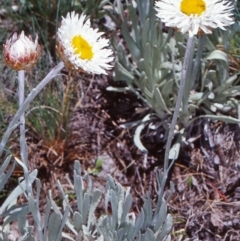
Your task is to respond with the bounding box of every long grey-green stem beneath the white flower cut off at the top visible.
[162,37,194,183]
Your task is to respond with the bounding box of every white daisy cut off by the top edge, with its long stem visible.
[156,0,234,181]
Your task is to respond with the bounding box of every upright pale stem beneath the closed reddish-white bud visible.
[18,70,32,194]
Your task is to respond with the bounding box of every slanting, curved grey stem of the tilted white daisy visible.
[0,62,64,156]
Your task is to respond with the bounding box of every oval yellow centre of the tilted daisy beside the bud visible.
[72,35,93,60]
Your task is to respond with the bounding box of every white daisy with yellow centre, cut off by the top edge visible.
[155,0,234,37]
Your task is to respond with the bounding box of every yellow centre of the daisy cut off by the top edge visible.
[181,0,206,16]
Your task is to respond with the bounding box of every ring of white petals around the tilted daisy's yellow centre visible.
[57,12,114,74]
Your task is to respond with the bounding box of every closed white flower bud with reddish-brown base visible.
[3,31,41,70]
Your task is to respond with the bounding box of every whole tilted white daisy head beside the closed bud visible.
[56,12,113,74]
